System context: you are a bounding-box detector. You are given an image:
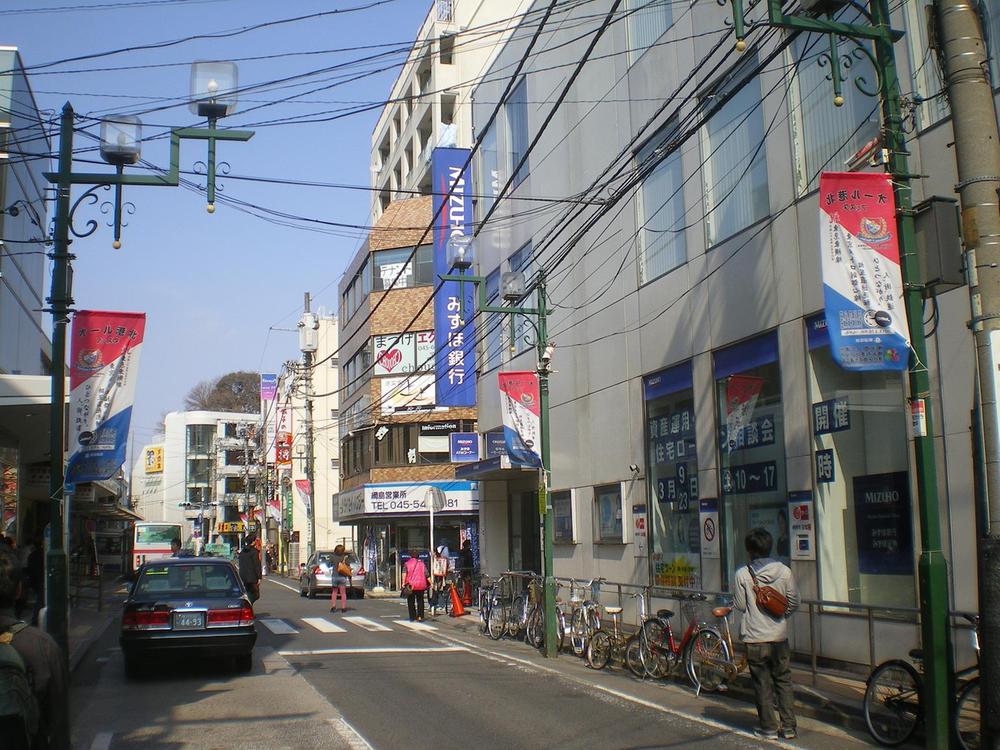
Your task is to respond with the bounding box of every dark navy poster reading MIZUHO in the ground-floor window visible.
[854,471,913,575]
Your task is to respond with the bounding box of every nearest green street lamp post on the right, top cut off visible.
[731,0,952,748]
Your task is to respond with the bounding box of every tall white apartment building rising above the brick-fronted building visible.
[371,0,541,224]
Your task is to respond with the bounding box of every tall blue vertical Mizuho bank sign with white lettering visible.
[431,148,476,406]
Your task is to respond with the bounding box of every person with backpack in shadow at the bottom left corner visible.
[0,549,70,750]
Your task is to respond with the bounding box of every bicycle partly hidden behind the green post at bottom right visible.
[863,615,982,750]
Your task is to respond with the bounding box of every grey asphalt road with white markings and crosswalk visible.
[72,579,866,750]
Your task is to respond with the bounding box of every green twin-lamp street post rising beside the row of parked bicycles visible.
[440,236,558,659]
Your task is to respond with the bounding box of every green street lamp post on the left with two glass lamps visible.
[45,62,253,659]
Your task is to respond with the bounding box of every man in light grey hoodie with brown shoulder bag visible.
[734,528,799,740]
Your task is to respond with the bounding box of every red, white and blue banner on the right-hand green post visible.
[819,172,910,370]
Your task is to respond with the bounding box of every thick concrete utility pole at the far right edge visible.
[934,0,1000,748]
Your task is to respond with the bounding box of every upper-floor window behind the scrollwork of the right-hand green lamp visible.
[789,28,880,195]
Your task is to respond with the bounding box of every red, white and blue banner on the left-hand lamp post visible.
[65,310,146,484]
